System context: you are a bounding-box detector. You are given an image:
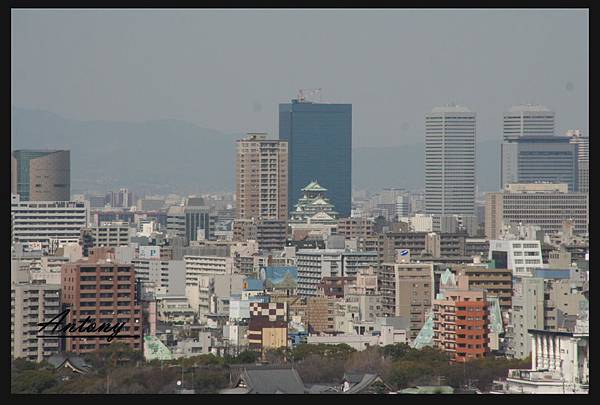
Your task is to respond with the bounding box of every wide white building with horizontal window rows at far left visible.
[11,194,89,250]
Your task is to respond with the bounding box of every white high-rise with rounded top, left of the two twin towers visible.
[425,105,475,215]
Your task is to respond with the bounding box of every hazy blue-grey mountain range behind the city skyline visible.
[11,107,500,194]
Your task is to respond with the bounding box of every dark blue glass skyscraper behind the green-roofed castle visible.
[279,100,352,217]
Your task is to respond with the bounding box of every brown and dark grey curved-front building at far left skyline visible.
[12,149,71,201]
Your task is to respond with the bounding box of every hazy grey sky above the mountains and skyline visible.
[11,9,589,146]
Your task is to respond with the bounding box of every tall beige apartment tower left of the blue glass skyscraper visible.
[236,133,288,221]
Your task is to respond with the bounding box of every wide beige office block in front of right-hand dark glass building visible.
[485,183,589,239]
